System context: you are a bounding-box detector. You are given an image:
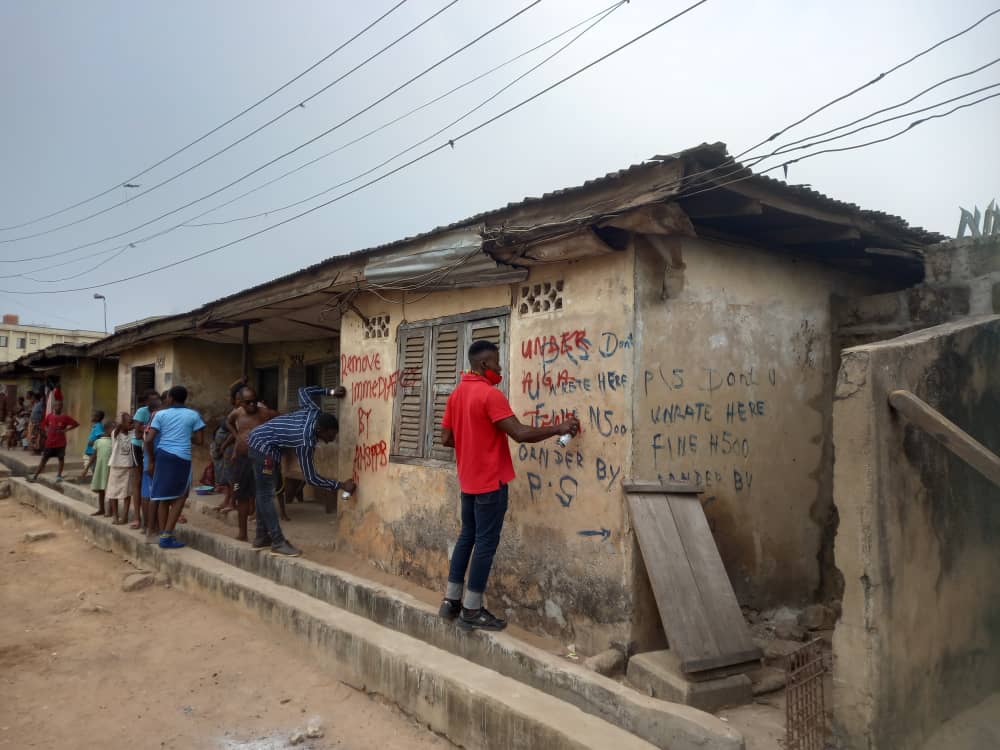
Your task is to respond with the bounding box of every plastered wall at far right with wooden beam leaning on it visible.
[833,317,1000,750]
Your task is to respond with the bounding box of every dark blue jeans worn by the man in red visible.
[450,485,507,594]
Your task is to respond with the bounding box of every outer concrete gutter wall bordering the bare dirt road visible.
[13,480,680,750]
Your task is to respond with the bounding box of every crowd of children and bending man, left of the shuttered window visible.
[15,379,357,557]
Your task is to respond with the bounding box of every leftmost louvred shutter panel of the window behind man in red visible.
[392,328,431,458]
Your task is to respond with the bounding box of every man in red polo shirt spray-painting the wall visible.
[439,341,580,630]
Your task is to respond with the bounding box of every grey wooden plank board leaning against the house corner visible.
[626,484,761,672]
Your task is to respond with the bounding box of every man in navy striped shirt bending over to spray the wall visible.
[247,386,357,557]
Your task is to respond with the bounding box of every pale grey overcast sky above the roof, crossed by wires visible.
[0,0,1000,330]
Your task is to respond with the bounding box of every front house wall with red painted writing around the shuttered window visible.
[329,252,634,652]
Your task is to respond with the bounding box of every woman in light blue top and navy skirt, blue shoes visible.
[144,385,205,549]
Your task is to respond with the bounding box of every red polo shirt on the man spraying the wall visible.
[441,373,514,495]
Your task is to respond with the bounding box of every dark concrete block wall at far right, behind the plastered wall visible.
[834,236,1000,347]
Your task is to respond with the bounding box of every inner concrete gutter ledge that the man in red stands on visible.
[17,480,744,750]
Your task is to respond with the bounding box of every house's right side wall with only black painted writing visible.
[631,239,880,608]
